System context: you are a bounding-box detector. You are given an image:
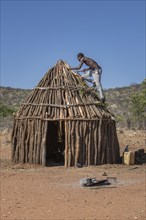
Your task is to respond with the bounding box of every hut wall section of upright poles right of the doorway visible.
[65,121,119,167]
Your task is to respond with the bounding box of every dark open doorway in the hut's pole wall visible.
[46,121,65,166]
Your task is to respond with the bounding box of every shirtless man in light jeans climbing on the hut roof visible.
[71,53,105,103]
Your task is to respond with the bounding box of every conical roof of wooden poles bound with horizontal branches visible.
[16,60,112,120]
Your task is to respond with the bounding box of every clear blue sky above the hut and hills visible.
[1,0,146,89]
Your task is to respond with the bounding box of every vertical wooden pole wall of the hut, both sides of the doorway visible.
[12,119,119,167]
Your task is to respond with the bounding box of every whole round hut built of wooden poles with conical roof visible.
[12,60,119,167]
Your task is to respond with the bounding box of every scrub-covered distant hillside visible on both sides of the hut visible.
[0,83,141,129]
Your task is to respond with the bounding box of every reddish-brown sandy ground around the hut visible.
[0,131,146,220]
